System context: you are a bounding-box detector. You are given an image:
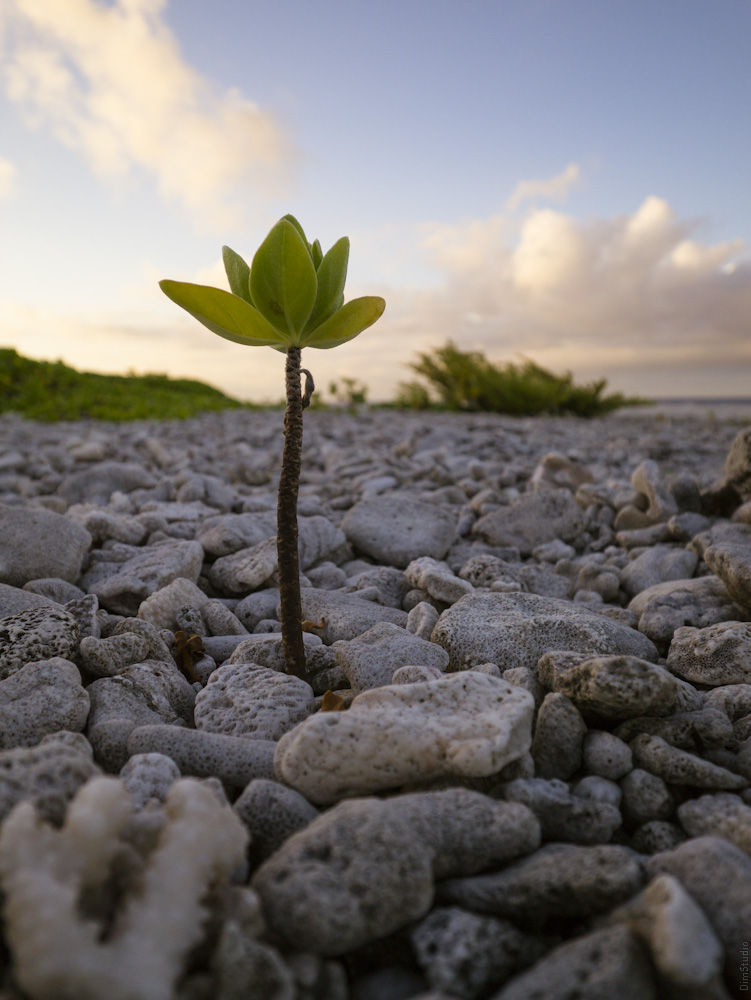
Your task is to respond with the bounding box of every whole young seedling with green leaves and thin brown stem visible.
[164,215,386,679]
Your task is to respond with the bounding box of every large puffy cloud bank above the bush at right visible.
[372,189,751,394]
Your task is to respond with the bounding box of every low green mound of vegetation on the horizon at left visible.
[0,347,250,421]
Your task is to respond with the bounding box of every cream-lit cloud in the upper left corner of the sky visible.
[0,0,297,229]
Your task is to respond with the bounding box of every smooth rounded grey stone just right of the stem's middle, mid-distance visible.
[342,496,456,569]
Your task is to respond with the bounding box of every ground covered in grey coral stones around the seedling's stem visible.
[0,411,751,1000]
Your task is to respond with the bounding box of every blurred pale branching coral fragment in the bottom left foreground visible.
[0,778,247,1000]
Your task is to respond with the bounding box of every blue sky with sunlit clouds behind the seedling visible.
[0,0,751,401]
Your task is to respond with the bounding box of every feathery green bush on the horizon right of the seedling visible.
[396,341,648,417]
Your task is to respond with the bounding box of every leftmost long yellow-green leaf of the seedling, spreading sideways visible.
[159,280,289,350]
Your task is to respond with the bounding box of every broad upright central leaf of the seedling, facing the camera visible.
[250,219,318,346]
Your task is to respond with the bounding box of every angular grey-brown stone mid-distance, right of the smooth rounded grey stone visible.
[472,489,585,556]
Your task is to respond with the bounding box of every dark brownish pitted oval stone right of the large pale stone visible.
[554,656,678,719]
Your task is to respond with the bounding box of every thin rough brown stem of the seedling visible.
[276,347,307,680]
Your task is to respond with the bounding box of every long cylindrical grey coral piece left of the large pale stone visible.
[127,724,276,788]
